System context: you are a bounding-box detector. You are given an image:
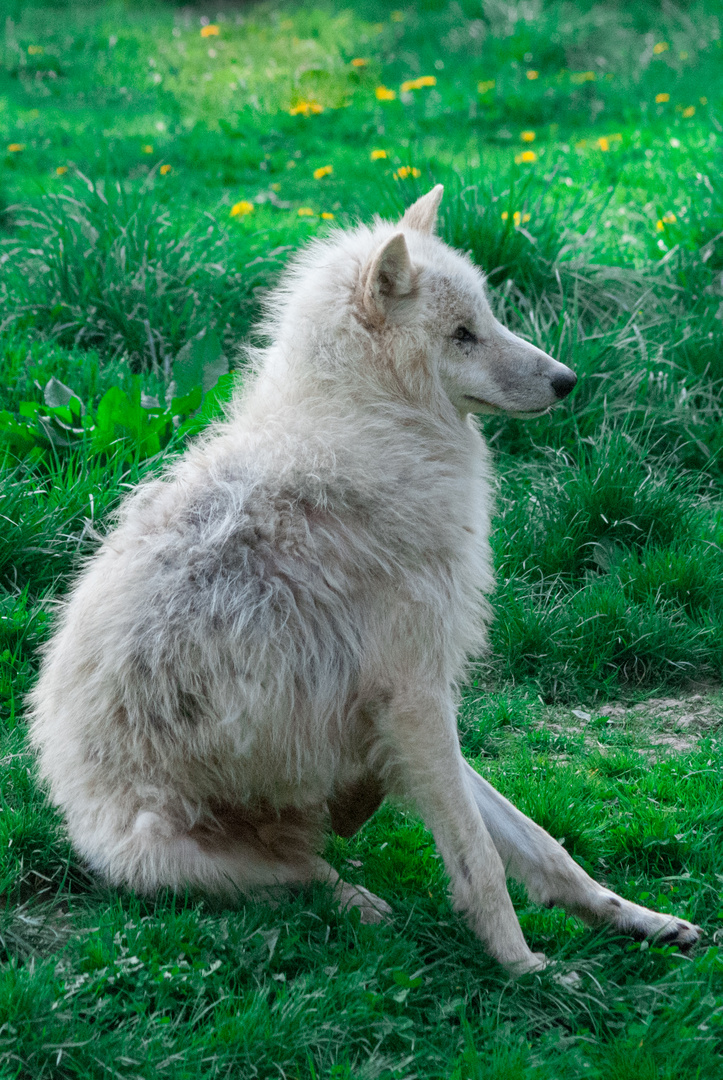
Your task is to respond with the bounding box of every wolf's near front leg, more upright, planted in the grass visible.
[378,689,545,974]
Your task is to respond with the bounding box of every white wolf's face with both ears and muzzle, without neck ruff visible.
[360,184,577,417]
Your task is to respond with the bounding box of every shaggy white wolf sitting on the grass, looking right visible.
[31,186,699,972]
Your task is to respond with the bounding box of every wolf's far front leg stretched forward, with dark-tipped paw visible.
[464,762,701,948]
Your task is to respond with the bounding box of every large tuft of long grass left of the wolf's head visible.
[6,177,287,372]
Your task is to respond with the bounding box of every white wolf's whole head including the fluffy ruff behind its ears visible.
[262,184,576,417]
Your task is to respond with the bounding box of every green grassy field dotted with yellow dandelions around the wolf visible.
[0,0,723,1080]
